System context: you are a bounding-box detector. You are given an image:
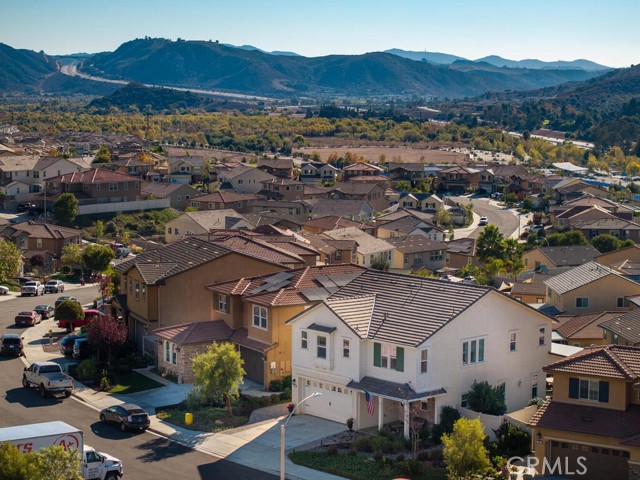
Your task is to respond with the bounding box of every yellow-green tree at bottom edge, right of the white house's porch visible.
[442,418,490,478]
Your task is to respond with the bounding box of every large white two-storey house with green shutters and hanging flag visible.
[288,270,552,437]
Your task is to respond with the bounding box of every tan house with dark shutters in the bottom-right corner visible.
[529,345,640,480]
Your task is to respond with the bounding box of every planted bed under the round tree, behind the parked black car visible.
[156,404,249,432]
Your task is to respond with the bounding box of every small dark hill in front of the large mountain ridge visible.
[88,83,202,112]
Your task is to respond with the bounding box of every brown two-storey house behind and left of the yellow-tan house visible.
[114,237,287,352]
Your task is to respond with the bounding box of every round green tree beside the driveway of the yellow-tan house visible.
[192,342,245,416]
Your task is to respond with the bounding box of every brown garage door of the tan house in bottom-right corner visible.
[546,441,629,480]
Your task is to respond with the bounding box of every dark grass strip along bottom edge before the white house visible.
[289,450,447,480]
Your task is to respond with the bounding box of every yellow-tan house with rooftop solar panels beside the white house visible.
[206,264,365,388]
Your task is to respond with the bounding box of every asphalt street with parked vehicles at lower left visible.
[0,288,277,480]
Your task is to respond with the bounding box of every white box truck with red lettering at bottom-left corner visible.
[0,422,123,480]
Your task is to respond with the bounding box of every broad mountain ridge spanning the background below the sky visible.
[81,38,595,97]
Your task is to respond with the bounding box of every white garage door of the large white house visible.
[303,381,355,423]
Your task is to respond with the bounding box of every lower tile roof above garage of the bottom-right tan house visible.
[529,399,640,446]
